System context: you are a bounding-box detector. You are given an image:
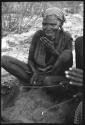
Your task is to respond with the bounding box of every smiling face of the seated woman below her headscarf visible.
[42,15,61,36]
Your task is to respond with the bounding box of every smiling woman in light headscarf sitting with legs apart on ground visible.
[1,7,72,85]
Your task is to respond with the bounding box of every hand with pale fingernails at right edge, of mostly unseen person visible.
[65,68,83,86]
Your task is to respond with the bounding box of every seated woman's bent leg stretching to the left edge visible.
[1,56,32,82]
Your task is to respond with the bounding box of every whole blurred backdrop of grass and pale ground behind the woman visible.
[1,1,84,61]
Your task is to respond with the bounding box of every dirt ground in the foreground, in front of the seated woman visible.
[1,71,77,123]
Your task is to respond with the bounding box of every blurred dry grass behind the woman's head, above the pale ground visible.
[2,1,83,36]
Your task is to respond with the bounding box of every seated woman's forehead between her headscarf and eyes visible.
[43,15,61,24]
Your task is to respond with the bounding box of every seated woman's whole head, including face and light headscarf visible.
[42,7,65,36]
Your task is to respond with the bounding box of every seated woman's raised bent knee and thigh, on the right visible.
[52,50,73,75]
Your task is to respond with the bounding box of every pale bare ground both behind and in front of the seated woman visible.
[1,15,83,123]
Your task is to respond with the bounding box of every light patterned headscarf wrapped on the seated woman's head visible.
[43,7,65,22]
